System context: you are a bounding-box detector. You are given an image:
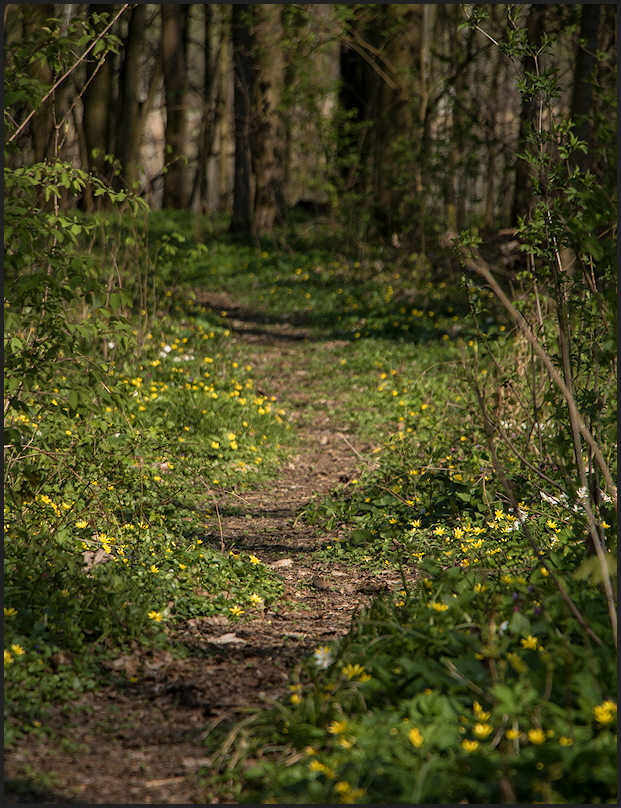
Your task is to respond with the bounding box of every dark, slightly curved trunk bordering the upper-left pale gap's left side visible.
[114,5,147,188]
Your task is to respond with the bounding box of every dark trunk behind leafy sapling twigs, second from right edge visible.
[511,3,546,225]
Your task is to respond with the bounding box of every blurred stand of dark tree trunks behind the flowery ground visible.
[4,4,617,243]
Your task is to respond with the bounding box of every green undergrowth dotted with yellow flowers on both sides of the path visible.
[5,205,616,803]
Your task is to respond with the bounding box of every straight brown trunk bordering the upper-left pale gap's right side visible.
[160,3,189,210]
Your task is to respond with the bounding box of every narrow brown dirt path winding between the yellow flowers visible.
[5,293,412,805]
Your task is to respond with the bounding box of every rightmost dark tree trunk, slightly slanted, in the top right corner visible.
[569,4,600,171]
